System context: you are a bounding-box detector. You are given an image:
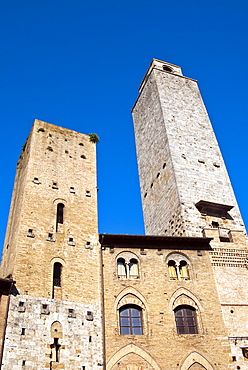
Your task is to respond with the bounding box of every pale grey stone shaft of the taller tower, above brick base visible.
[133,60,244,236]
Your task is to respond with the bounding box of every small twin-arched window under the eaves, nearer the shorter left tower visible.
[117,252,139,279]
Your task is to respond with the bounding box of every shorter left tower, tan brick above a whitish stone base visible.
[1,120,102,370]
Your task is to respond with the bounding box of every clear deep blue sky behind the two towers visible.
[0,0,248,254]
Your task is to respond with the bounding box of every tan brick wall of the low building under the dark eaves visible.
[102,245,230,370]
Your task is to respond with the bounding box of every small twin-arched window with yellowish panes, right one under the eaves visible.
[167,253,189,280]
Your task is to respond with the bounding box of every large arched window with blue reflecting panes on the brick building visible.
[119,305,143,335]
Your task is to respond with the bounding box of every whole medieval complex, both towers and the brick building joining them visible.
[0,59,248,370]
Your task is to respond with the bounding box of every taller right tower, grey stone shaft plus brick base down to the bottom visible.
[132,59,248,369]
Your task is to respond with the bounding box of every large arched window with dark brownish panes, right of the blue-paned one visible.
[174,305,198,334]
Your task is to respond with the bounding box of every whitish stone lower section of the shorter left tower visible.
[2,295,102,370]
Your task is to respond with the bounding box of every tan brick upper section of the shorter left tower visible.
[2,120,99,302]
